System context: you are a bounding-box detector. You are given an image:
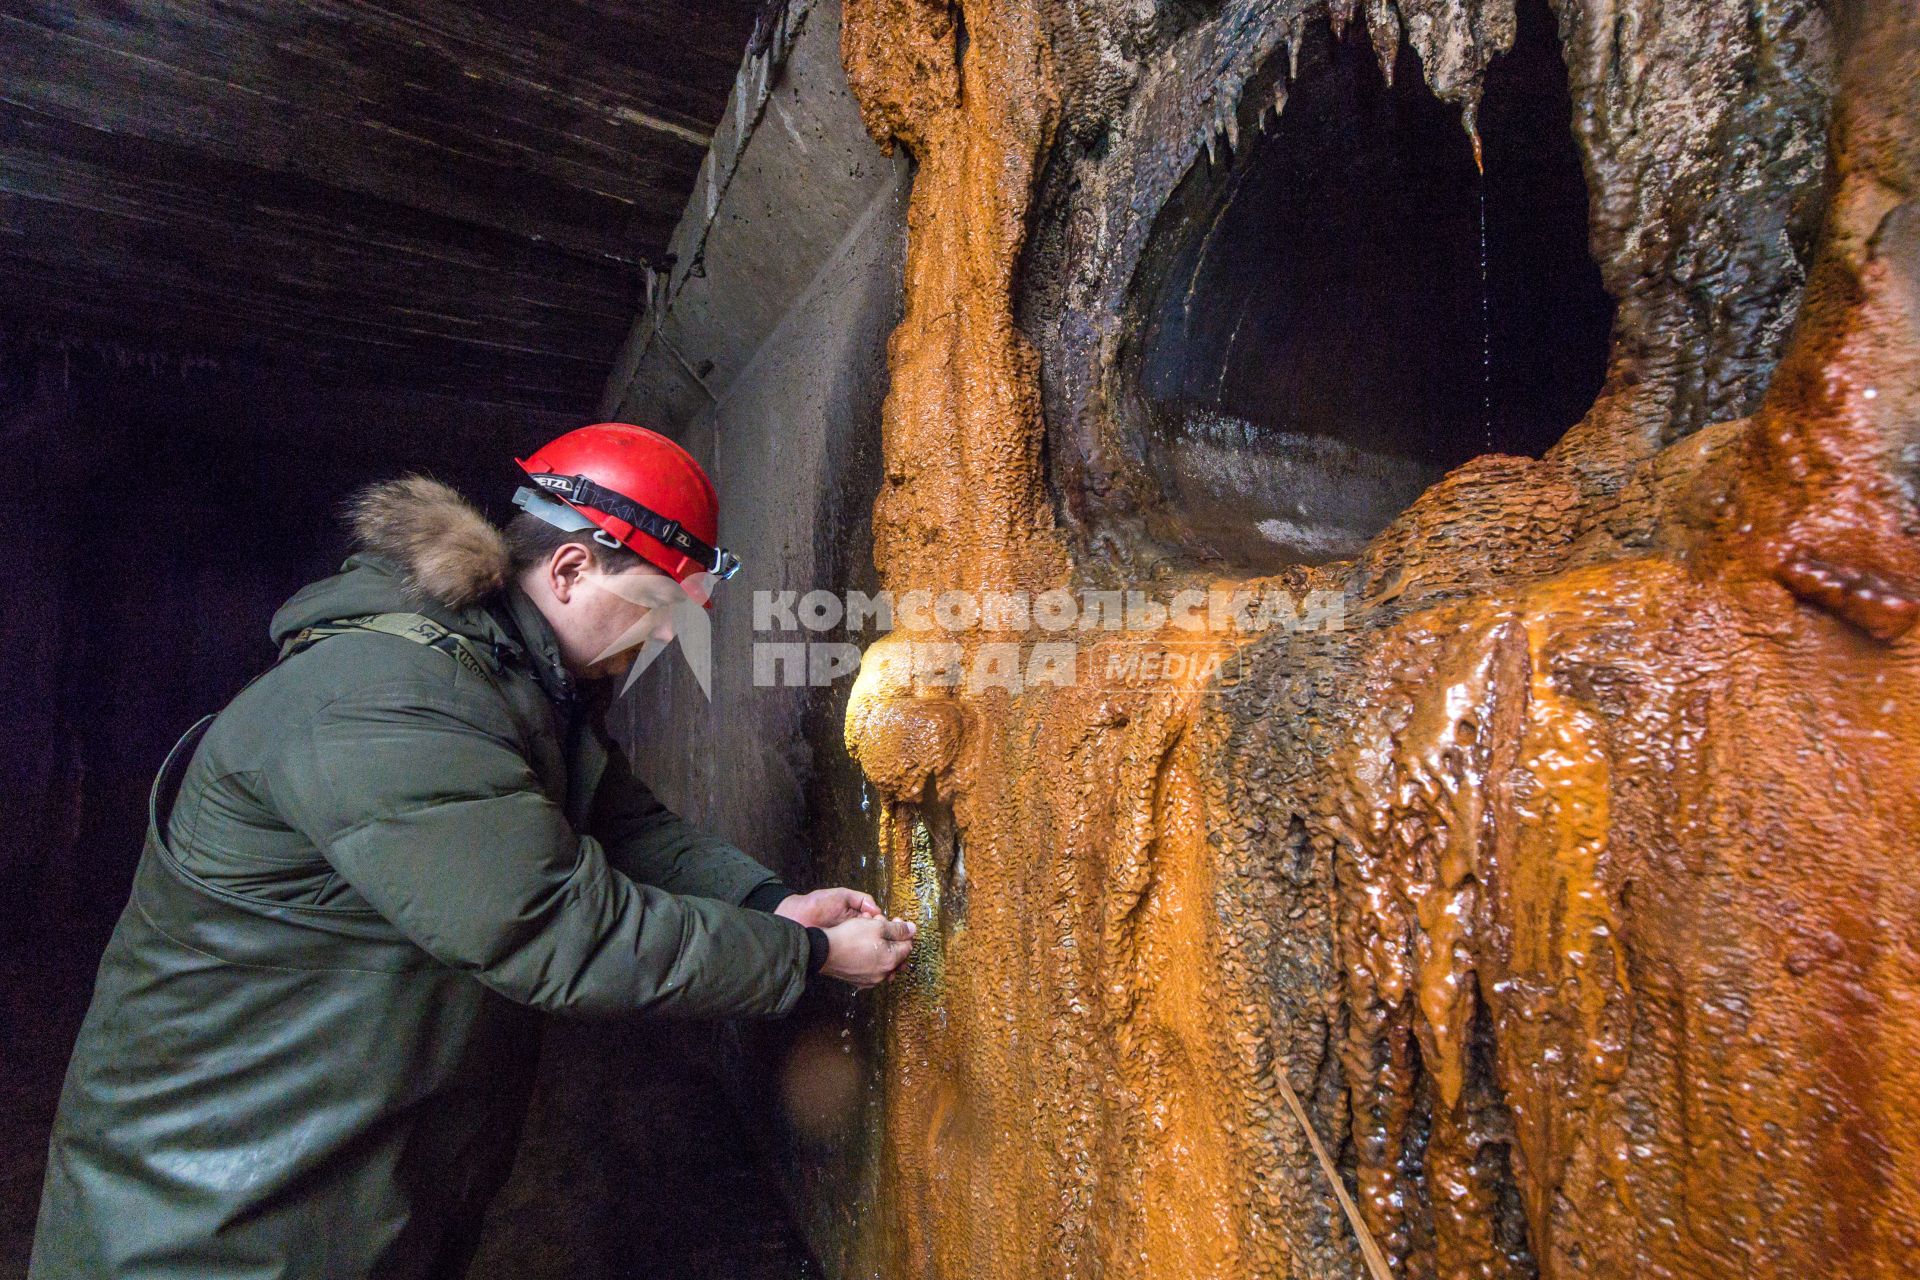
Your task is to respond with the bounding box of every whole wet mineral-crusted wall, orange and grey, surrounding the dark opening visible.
[845,0,1920,1278]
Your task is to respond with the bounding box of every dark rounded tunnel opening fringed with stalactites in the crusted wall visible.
[1119,0,1613,568]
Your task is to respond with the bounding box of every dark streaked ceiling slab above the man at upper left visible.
[0,0,760,411]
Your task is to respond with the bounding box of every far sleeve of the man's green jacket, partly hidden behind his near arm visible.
[588,727,785,910]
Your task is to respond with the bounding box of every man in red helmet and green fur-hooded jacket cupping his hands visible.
[31,424,914,1280]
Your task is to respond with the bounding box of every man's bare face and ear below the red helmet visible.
[507,512,687,679]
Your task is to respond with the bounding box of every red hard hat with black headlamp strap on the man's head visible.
[513,422,739,608]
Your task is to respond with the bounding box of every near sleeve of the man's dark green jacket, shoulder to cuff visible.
[273,671,808,1017]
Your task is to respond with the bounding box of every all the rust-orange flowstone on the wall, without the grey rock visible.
[845,0,1920,1280]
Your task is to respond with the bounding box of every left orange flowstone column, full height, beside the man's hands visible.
[845,4,1267,1276]
